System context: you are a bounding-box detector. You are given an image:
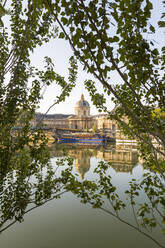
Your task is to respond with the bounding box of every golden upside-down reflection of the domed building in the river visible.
[51,146,138,179]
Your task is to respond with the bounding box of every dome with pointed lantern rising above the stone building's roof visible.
[75,94,90,117]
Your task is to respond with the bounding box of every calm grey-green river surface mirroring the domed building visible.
[0,142,165,248]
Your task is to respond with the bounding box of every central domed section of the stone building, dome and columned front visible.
[68,94,94,130]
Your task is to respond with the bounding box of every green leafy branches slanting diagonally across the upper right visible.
[45,0,165,174]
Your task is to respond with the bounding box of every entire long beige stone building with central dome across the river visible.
[31,94,117,137]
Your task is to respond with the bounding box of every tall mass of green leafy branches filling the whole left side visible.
[0,0,77,232]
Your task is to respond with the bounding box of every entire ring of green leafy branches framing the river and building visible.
[0,0,165,247]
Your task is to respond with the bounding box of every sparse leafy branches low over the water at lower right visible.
[65,161,165,248]
